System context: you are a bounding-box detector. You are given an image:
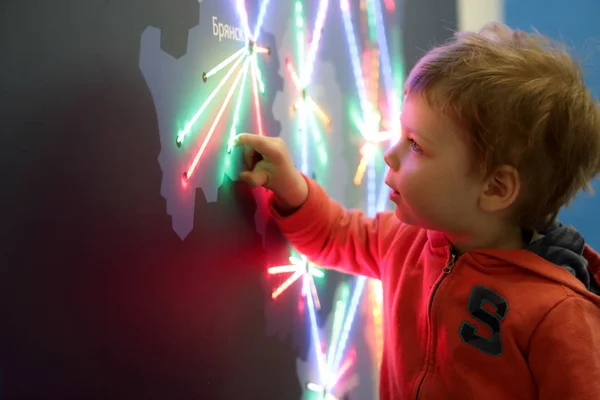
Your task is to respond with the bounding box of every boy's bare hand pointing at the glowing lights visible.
[234,133,308,212]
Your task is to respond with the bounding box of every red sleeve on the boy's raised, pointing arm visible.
[269,173,400,279]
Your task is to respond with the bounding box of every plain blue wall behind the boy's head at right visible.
[505,0,600,249]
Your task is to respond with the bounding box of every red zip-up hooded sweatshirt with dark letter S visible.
[270,179,600,400]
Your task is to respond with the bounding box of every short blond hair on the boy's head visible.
[406,23,600,229]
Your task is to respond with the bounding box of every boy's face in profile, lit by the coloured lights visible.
[385,94,484,233]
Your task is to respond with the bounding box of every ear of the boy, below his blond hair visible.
[479,165,521,212]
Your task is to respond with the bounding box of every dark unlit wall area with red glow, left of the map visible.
[0,0,301,399]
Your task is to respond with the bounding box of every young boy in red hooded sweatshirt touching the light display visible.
[237,24,600,400]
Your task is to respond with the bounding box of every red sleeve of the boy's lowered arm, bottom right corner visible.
[529,297,600,400]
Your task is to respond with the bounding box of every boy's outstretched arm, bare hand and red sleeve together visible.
[234,134,398,278]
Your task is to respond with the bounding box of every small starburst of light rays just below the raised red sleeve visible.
[268,255,325,309]
